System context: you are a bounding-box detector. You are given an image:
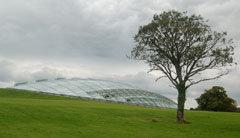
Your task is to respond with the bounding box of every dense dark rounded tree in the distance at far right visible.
[196,86,237,112]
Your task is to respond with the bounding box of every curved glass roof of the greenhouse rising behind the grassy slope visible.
[11,78,177,108]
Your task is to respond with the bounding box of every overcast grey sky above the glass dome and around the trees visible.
[0,0,240,108]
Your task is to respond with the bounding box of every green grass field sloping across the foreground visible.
[0,89,240,138]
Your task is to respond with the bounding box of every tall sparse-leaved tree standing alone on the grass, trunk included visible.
[131,10,234,123]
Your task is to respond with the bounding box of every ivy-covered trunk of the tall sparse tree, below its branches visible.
[177,85,186,123]
